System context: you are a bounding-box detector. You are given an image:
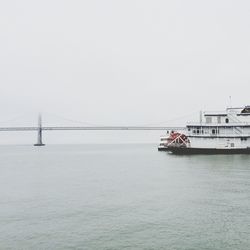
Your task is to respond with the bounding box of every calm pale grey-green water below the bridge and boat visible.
[0,144,250,250]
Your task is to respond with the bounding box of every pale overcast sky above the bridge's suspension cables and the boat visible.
[0,0,250,143]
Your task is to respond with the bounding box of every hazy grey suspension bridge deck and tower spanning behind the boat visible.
[0,115,184,146]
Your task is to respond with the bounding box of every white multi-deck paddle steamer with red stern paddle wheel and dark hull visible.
[158,106,250,154]
